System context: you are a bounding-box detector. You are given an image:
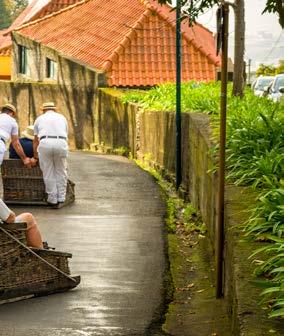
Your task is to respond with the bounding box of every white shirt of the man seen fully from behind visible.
[34,110,68,138]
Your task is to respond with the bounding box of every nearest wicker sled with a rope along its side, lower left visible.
[0,223,80,304]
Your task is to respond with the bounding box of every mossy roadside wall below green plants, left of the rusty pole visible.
[138,111,217,242]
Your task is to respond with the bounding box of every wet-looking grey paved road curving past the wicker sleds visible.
[0,152,165,336]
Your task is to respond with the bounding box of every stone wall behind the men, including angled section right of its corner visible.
[0,83,137,157]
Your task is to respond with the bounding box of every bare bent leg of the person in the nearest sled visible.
[16,212,43,248]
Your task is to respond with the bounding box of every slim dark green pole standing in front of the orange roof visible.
[176,0,181,190]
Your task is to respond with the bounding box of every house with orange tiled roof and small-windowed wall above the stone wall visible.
[12,0,220,87]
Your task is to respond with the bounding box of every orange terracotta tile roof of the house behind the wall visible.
[17,0,219,86]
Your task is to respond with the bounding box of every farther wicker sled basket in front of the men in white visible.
[1,159,75,205]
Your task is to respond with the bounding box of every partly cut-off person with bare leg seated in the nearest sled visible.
[0,198,43,249]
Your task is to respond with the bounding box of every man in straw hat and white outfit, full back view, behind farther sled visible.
[34,102,68,205]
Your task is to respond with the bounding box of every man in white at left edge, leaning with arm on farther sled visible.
[0,104,31,167]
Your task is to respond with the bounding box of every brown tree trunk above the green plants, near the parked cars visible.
[233,0,245,97]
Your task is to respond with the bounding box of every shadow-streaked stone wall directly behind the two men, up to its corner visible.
[0,81,96,149]
